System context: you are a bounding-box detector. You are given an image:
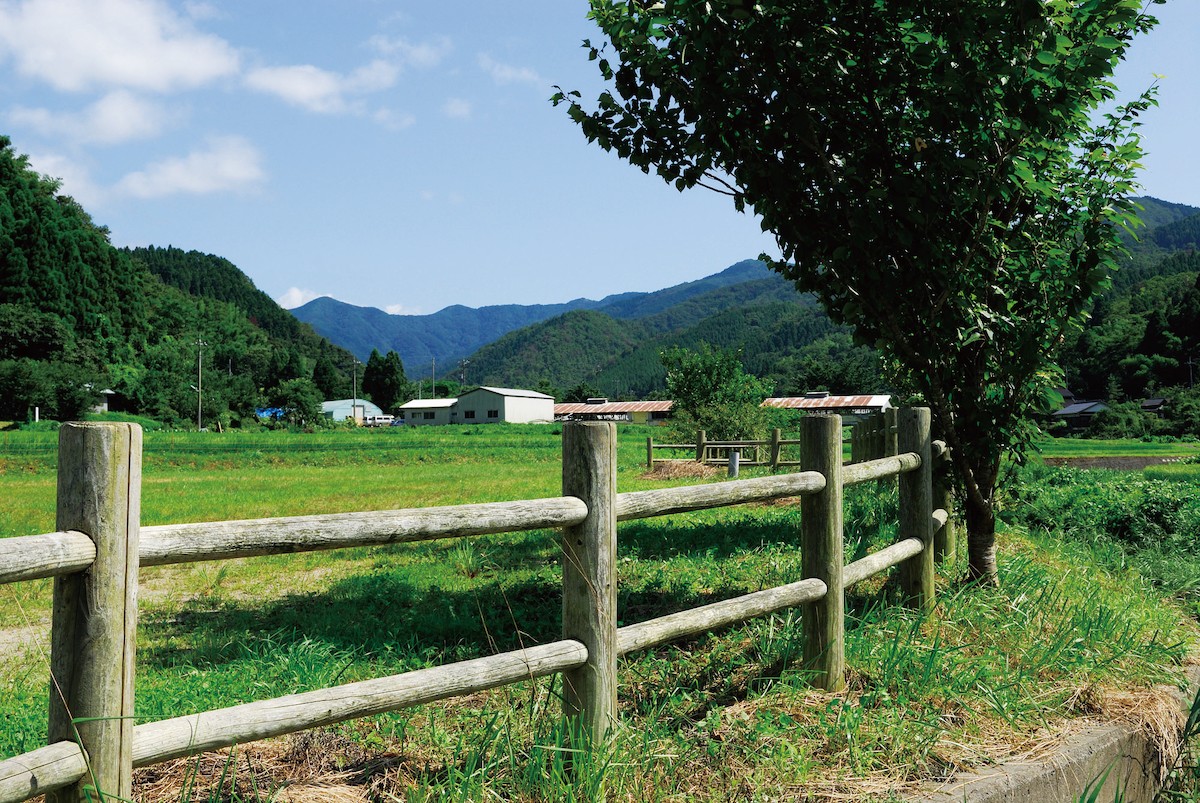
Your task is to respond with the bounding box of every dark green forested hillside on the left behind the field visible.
[0,138,350,426]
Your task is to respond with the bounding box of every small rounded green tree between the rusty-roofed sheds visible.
[660,343,770,441]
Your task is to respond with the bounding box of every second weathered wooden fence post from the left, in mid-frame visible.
[563,423,617,744]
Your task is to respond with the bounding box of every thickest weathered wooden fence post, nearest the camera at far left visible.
[47,424,142,803]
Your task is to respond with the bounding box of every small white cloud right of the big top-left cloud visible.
[246,59,400,114]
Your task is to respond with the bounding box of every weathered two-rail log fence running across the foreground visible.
[0,408,949,803]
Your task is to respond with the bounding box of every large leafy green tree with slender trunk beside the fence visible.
[554,0,1162,581]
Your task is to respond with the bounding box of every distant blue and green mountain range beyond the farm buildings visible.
[293,198,1200,397]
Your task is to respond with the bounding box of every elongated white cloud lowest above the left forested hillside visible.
[116,137,265,198]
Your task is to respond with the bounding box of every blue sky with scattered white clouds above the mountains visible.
[0,0,1200,313]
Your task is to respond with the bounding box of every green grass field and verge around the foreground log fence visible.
[0,426,1195,801]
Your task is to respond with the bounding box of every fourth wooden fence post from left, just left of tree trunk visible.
[896,407,936,611]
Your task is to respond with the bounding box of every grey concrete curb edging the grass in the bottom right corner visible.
[908,666,1200,803]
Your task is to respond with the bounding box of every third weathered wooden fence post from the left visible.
[800,415,846,691]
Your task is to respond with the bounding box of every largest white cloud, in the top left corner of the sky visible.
[0,0,239,92]
